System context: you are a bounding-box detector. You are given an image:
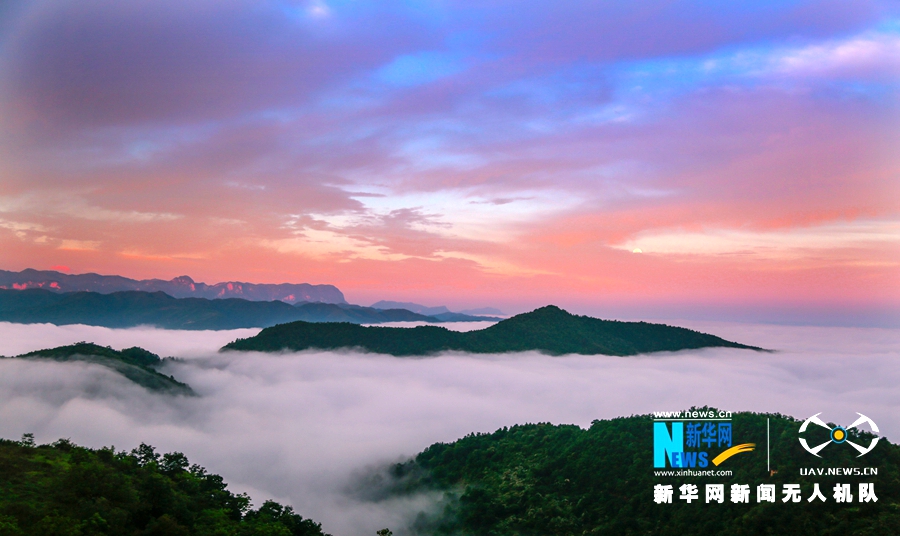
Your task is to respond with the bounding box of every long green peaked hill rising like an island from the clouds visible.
[223,305,759,356]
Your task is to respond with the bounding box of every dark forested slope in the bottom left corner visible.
[0,435,327,536]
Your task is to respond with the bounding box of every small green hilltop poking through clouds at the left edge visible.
[5,342,194,395]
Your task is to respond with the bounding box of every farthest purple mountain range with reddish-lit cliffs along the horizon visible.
[0,268,347,303]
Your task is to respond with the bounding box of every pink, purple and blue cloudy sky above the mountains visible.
[0,0,900,325]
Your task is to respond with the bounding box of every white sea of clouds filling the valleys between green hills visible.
[0,322,900,536]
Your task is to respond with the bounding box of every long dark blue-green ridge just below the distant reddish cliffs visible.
[0,289,485,330]
